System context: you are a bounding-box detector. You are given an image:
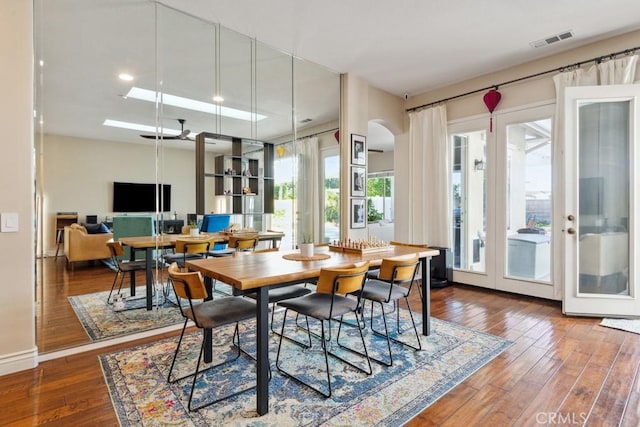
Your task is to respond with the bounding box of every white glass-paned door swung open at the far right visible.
[562,85,640,317]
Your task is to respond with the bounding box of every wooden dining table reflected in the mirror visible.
[118,231,284,310]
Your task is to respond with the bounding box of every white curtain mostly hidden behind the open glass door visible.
[553,55,638,298]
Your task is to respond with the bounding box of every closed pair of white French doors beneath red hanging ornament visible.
[449,105,558,298]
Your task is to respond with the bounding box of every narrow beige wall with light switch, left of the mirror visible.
[0,0,37,375]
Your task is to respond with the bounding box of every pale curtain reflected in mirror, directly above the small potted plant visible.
[293,137,322,243]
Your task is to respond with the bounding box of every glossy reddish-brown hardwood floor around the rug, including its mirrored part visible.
[5,258,640,426]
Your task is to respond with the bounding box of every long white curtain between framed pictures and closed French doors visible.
[403,105,452,248]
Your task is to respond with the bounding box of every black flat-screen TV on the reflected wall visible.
[113,182,171,212]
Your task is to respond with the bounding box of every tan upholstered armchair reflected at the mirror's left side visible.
[64,224,113,267]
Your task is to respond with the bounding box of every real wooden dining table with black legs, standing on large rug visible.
[186,245,440,415]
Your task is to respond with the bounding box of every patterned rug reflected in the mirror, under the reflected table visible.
[68,286,183,341]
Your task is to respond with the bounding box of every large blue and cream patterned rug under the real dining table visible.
[100,311,511,426]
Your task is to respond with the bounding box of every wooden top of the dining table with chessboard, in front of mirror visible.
[186,246,440,290]
